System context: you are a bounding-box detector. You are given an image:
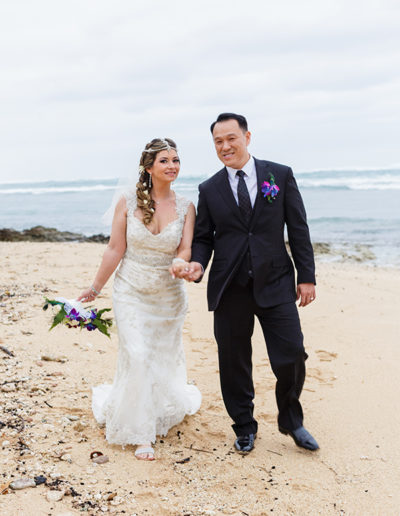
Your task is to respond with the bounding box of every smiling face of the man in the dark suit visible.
[213,119,251,170]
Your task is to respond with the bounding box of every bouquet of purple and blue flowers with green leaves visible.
[43,297,112,337]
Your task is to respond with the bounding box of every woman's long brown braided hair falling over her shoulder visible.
[136,138,177,226]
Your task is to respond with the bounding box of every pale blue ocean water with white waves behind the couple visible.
[0,169,400,267]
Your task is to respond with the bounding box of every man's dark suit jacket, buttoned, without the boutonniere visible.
[192,159,315,310]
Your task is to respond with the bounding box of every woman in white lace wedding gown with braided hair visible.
[78,138,201,460]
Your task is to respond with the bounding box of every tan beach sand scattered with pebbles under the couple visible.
[0,242,400,516]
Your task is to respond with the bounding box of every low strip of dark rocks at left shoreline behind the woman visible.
[0,226,109,243]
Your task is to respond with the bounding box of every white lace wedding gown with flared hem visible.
[92,193,201,445]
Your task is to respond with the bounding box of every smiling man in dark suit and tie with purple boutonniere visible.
[182,113,318,454]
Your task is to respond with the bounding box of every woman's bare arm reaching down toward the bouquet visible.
[78,197,127,301]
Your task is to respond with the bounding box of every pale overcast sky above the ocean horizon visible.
[0,0,400,182]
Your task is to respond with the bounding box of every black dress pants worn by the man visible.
[214,280,307,435]
